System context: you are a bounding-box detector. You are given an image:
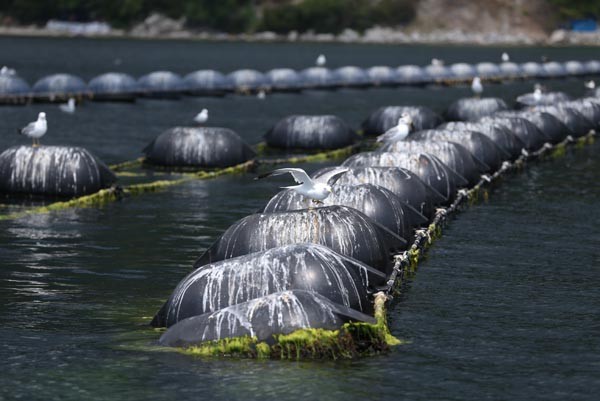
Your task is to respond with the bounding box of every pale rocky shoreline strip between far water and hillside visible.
[0,26,600,47]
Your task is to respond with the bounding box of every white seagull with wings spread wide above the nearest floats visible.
[255,167,349,203]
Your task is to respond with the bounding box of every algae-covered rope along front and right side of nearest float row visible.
[159,131,596,360]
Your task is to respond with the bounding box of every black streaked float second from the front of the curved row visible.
[152,244,386,327]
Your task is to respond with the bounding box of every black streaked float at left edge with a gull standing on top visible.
[0,146,116,197]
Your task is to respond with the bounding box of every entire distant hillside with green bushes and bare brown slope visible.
[0,0,600,37]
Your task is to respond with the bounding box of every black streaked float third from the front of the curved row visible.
[194,206,406,275]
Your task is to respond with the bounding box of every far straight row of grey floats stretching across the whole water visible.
[0,60,600,105]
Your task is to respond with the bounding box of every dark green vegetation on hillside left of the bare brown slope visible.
[0,0,416,32]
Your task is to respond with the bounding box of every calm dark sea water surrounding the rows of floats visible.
[0,38,600,400]
